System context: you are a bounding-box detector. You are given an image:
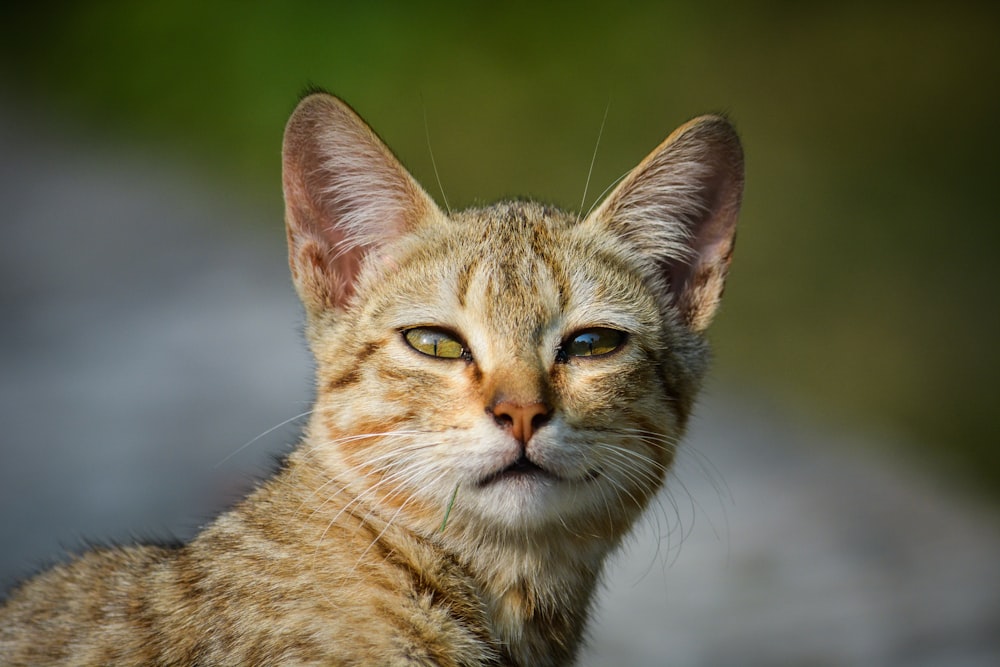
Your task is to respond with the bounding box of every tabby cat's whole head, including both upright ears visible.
[284,94,743,538]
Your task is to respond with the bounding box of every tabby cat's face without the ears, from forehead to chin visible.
[314,203,687,532]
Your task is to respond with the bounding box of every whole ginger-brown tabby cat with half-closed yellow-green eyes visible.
[0,92,744,666]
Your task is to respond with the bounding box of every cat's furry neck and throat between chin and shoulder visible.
[278,448,618,665]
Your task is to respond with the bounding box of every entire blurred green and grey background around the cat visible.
[0,1,1000,665]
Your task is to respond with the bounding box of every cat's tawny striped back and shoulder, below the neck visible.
[0,480,496,667]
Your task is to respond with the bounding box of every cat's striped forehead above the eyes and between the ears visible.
[369,201,648,340]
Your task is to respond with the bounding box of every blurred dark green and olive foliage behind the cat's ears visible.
[0,0,1000,493]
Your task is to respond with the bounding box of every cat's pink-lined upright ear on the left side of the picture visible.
[282,93,440,314]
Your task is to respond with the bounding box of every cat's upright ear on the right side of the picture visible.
[588,116,743,331]
